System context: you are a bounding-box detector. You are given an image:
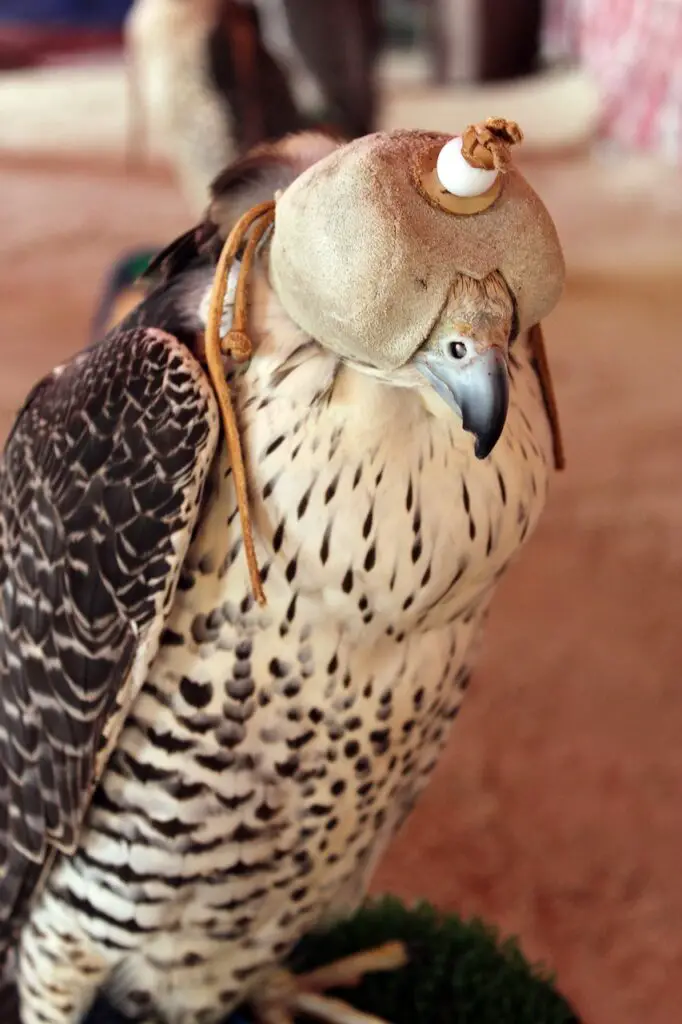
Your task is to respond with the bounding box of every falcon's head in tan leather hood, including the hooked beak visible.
[268,119,564,459]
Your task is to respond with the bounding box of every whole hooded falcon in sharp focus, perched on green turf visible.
[0,119,563,1024]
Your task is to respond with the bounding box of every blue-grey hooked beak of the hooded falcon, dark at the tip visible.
[415,340,509,459]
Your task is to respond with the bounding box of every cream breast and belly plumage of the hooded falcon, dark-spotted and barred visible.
[23,323,551,1024]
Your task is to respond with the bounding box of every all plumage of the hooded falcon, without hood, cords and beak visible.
[0,136,552,1024]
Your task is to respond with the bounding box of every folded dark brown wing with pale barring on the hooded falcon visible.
[0,328,219,950]
